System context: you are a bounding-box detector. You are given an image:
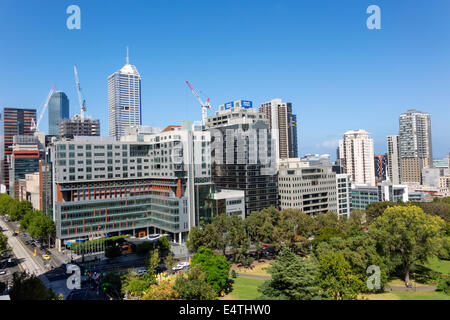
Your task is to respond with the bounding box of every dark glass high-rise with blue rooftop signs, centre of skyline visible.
[207,101,278,216]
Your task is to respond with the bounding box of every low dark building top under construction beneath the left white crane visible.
[59,115,100,139]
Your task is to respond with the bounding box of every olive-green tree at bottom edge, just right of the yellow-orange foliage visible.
[173,265,217,300]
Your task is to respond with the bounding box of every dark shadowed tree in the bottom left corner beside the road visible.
[9,272,56,300]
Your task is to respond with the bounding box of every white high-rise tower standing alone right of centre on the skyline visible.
[339,129,375,186]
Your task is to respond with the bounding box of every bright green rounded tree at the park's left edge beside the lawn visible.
[191,247,230,293]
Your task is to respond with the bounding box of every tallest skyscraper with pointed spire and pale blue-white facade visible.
[108,50,142,140]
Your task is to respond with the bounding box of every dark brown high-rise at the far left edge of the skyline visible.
[0,108,36,191]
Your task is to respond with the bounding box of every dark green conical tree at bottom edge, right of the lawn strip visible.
[258,247,325,300]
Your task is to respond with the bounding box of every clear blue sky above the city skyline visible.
[0,0,450,158]
